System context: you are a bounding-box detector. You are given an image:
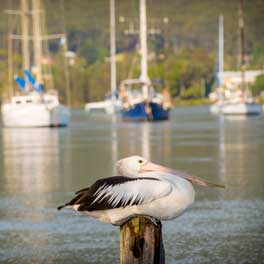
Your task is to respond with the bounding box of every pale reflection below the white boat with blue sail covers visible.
[2,128,60,193]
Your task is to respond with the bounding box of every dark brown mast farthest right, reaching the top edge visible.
[239,0,245,91]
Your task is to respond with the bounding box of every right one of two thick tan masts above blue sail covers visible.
[32,0,42,83]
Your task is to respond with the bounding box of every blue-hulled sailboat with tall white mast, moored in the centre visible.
[119,0,171,121]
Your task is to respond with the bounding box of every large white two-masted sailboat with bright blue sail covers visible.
[1,0,70,127]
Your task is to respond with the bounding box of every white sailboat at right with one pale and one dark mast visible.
[210,0,262,115]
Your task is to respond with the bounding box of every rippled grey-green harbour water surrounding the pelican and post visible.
[0,107,264,264]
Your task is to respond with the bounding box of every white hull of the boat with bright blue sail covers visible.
[2,104,70,127]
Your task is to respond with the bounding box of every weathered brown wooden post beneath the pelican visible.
[120,216,165,264]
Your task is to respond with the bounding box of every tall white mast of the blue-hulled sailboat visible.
[140,0,149,99]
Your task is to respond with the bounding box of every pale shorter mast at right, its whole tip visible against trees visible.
[217,15,224,86]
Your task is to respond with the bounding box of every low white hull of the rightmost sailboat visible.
[210,103,262,115]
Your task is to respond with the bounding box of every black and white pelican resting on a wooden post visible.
[58,156,224,225]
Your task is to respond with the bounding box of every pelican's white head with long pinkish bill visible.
[116,156,225,188]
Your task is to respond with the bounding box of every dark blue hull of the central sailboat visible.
[121,102,170,121]
